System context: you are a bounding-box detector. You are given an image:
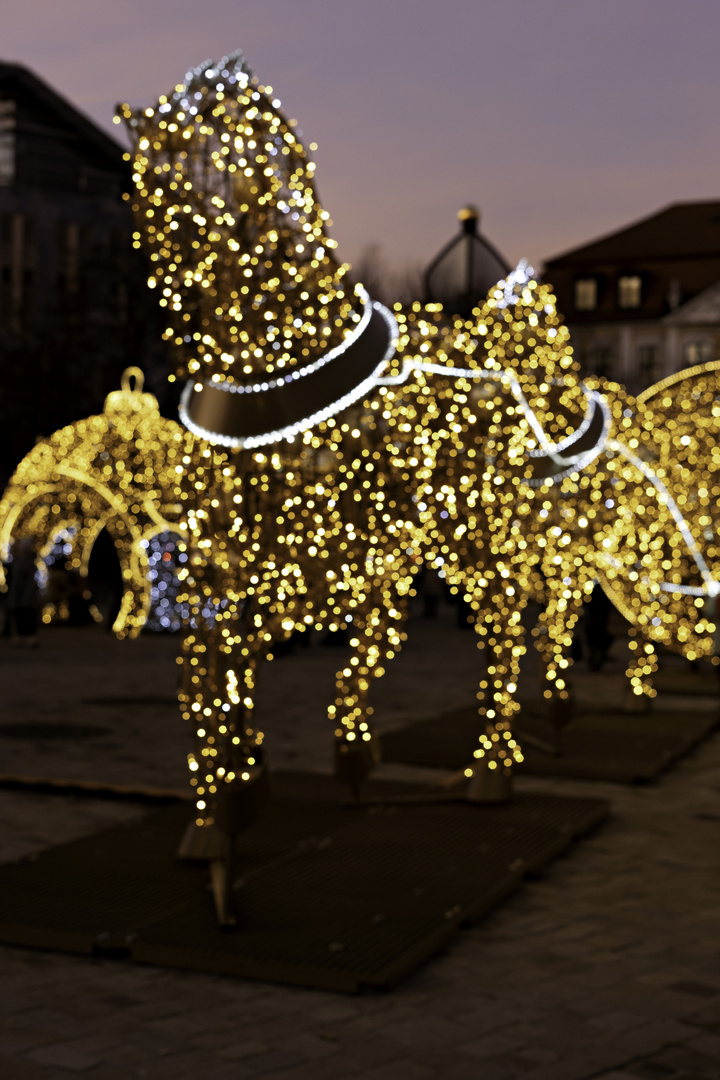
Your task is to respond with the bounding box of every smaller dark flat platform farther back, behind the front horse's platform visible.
[381,705,720,784]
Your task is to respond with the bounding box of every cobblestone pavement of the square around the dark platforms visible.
[0,608,720,1080]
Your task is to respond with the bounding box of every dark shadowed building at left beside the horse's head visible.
[0,63,162,481]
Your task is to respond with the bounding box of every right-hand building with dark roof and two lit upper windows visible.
[543,201,720,392]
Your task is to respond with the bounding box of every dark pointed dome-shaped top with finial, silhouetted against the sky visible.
[425,206,511,318]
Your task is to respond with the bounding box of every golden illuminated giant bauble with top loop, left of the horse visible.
[0,368,189,637]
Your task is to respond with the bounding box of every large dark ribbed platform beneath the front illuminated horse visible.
[0,773,608,991]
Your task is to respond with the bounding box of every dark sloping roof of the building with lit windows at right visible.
[545,200,720,270]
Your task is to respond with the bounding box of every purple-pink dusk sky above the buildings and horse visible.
[5,0,720,282]
